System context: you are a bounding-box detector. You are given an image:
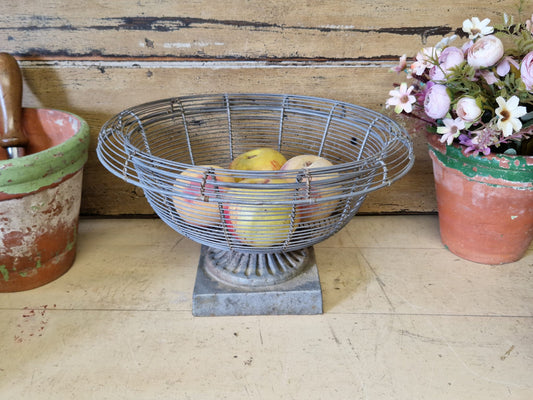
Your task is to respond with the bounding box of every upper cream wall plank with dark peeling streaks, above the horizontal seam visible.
[0,0,516,60]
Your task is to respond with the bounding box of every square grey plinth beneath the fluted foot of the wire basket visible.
[192,246,322,317]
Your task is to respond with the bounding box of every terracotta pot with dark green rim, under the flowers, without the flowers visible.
[428,134,533,264]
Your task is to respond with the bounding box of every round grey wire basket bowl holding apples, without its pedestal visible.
[97,94,414,253]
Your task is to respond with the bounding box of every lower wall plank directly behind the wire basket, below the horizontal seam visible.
[16,62,435,215]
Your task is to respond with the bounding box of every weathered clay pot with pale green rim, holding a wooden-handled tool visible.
[0,108,89,292]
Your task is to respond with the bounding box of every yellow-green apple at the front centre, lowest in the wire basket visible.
[224,178,298,247]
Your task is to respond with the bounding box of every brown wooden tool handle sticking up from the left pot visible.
[0,53,28,148]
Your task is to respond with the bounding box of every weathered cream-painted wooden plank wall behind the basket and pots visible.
[0,0,533,215]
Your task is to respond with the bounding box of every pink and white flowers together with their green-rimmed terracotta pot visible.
[386,10,533,264]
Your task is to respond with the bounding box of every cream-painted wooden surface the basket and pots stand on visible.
[0,216,533,400]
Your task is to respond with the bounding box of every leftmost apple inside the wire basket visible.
[172,165,235,226]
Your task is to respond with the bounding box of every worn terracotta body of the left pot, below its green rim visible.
[0,170,83,292]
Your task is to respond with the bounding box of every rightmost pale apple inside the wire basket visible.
[281,154,342,222]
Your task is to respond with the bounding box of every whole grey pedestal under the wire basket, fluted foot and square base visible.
[192,245,322,316]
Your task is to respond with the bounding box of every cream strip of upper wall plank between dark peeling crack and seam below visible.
[0,27,450,61]
